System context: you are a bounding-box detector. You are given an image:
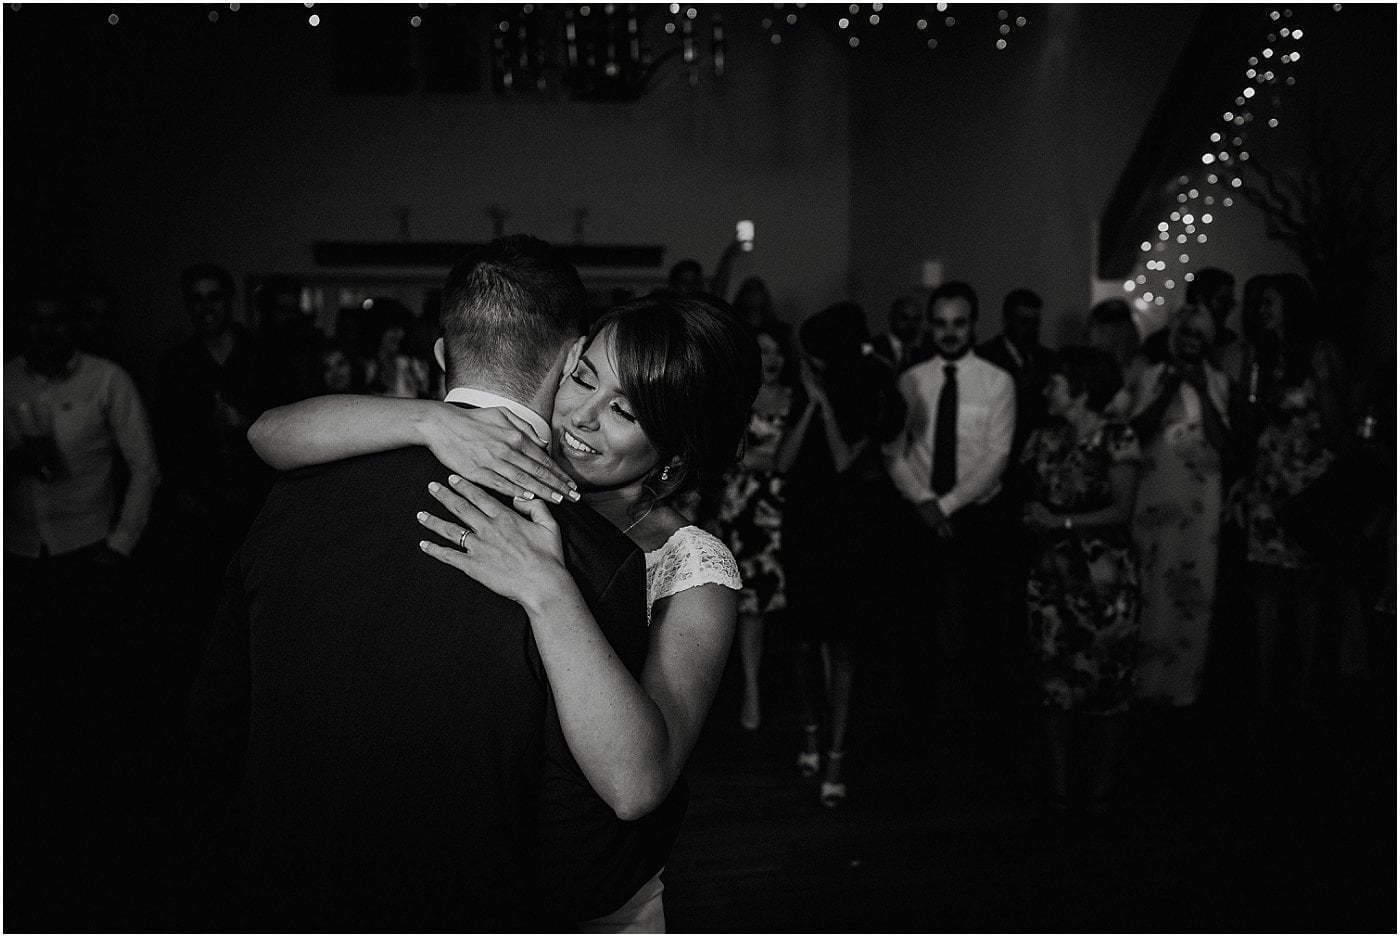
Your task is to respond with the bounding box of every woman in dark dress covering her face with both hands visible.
[777,303,903,807]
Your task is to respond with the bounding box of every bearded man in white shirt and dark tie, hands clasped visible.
[885,282,1016,705]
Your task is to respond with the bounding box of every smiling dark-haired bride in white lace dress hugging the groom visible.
[255,294,759,933]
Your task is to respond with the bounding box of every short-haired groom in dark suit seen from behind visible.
[190,235,685,931]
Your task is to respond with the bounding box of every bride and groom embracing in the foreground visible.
[190,235,759,933]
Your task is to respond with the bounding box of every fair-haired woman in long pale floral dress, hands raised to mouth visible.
[1133,305,1232,707]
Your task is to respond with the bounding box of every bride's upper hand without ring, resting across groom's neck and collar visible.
[419,406,578,503]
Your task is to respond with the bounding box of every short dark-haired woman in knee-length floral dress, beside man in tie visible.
[1021,347,1142,810]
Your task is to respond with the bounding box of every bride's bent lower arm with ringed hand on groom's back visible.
[419,482,738,819]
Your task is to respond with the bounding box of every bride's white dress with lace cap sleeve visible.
[580,527,742,934]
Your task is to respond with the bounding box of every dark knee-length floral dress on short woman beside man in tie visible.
[1021,422,1142,714]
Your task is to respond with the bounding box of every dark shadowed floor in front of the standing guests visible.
[4,613,1396,933]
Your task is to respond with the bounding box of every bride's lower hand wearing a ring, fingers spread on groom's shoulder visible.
[419,475,573,611]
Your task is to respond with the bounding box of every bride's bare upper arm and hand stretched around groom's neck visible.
[248,394,577,501]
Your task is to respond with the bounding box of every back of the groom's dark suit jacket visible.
[197,448,644,930]
